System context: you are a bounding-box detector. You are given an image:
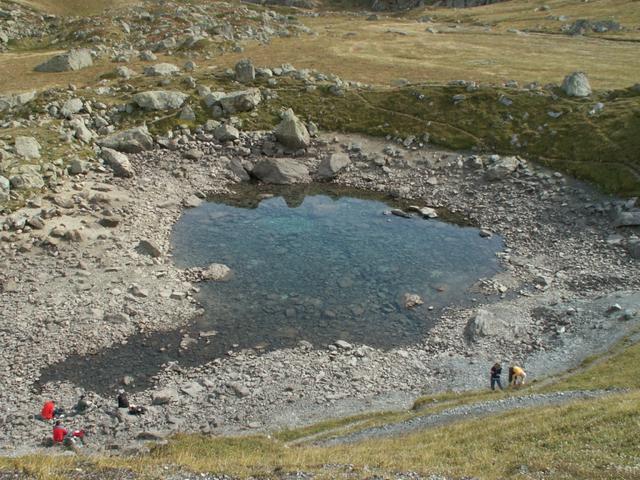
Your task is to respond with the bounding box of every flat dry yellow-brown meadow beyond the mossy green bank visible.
[218,17,640,88]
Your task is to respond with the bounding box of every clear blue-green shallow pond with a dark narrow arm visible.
[41,189,503,393]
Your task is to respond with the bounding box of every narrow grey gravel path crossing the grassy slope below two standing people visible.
[316,390,611,446]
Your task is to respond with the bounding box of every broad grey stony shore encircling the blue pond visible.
[0,124,640,455]
